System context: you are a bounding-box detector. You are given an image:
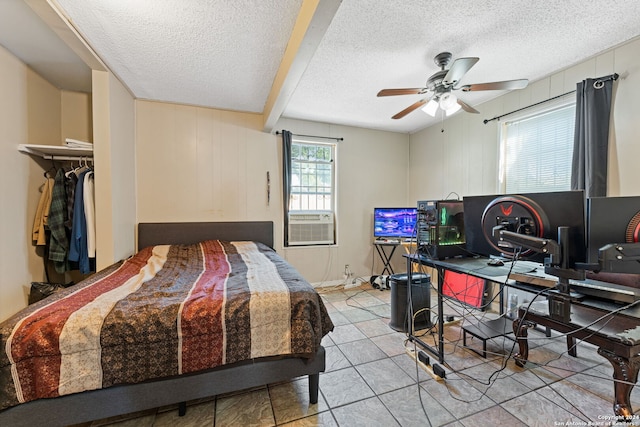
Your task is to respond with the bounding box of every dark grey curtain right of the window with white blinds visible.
[571,75,617,197]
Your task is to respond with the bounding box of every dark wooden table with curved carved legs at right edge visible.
[513,301,640,417]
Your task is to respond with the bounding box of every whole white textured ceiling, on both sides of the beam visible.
[0,0,640,132]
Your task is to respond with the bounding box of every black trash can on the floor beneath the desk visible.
[389,273,431,332]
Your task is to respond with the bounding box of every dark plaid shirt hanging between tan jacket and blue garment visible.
[48,168,69,273]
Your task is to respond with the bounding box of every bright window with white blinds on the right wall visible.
[500,102,576,194]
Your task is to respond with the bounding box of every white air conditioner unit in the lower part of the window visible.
[289,211,335,246]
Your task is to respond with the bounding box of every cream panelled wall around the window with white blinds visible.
[409,40,640,200]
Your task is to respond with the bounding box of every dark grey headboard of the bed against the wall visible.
[138,221,273,250]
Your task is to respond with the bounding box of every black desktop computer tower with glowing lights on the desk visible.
[416,200,467,259]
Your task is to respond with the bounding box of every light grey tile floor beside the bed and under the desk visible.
[86,284,640,427]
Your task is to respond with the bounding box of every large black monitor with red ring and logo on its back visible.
[463,191,587,268]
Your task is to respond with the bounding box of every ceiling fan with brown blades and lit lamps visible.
[378,52,529,119]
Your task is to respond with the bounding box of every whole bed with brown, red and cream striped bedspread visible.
[0,221,333,426]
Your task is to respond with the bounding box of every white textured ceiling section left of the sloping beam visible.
[58,0,302,113]
